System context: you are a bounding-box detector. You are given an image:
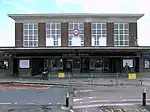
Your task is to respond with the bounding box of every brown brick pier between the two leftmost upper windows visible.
[38,23,46,47]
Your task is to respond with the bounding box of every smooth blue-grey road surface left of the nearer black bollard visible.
[0,87,73,105]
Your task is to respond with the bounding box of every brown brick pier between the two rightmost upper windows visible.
[107,23,114,47]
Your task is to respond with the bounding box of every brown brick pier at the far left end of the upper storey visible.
[15,23,23,47]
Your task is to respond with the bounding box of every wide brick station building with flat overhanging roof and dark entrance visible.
[1,13,150,75]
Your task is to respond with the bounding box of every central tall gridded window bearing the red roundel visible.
[68,23,84,46]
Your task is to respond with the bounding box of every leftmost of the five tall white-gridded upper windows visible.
[23,23,38,47]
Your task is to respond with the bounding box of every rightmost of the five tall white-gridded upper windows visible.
[114,23,129,46]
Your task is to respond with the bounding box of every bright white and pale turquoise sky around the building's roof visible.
[0,0,150,47]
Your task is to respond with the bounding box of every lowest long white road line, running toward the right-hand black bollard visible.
[74,103,150,109]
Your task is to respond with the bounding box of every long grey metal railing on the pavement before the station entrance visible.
[44,72,143,86]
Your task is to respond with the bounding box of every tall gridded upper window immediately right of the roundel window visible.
[92,22,107,46]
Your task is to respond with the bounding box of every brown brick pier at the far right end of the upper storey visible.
[129,23,137,46]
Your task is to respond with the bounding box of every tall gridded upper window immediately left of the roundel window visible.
[46,23,61,46]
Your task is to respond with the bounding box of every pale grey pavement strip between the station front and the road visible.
[0,77,146,86]
